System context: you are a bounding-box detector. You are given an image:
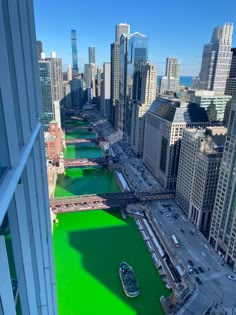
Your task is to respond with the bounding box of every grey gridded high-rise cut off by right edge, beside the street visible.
[209,96,236,271]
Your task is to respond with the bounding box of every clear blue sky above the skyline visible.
[34,0,236,75]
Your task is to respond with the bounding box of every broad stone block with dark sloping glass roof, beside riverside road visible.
[143,98,209,189]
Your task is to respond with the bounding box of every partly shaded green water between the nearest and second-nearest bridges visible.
[54,167,120,198]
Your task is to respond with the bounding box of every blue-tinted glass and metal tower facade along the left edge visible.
[0,0,57,315]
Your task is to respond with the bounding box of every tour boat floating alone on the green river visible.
[119,261,139,297]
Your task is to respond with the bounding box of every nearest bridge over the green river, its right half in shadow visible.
[50,192,174,214]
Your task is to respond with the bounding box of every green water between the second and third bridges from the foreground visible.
[64,144,104,159]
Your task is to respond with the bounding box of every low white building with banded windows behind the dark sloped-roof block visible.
[188,90,232,122]
